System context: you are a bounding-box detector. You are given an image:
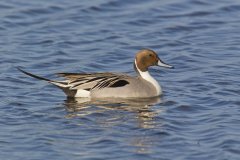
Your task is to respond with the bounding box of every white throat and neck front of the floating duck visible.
[135,60,162,95]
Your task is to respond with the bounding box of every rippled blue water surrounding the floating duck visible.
[0,0,240,160]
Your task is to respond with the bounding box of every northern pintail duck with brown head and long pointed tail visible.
[18,49,173,98]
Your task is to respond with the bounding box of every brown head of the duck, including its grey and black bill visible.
[135,49,173,72]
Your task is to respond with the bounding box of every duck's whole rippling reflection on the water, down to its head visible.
[65,97,165,154]
